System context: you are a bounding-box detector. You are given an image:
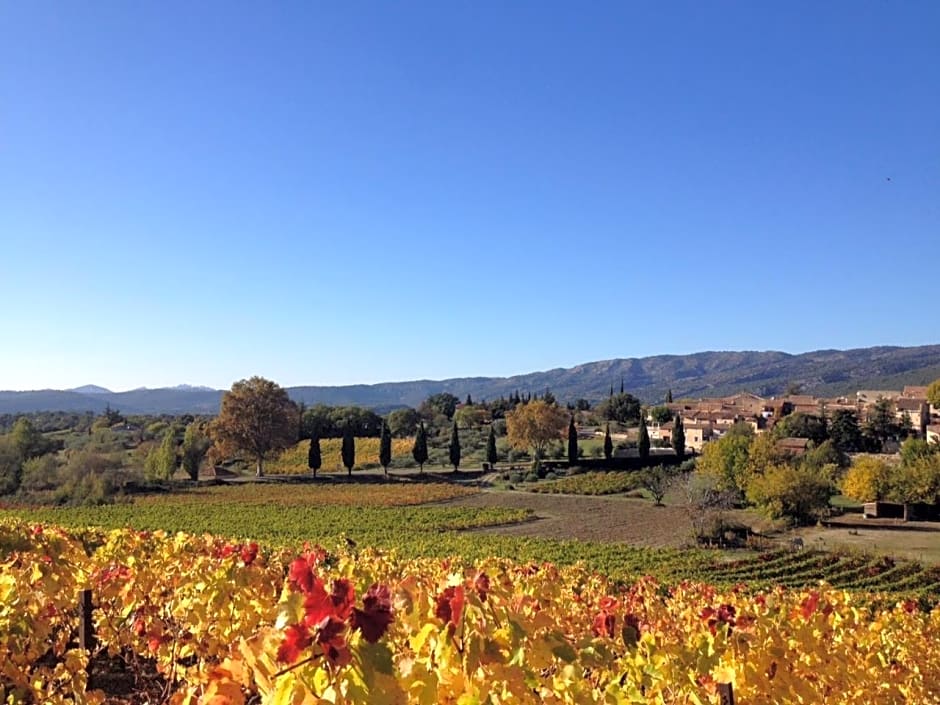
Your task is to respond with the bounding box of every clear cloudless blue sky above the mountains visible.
[0,0,940,390]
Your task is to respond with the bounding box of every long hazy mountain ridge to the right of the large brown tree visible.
[290,345,940,408]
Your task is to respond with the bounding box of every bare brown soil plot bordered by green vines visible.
[449,491,691,547]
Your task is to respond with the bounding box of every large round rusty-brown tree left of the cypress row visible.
[209,377,297,477]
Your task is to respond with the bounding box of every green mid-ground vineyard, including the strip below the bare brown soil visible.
[0,482,940,606]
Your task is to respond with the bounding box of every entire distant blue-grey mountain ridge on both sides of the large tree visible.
[0,345,940,414]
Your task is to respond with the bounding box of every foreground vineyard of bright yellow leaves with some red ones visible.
[0,520,940,705]
